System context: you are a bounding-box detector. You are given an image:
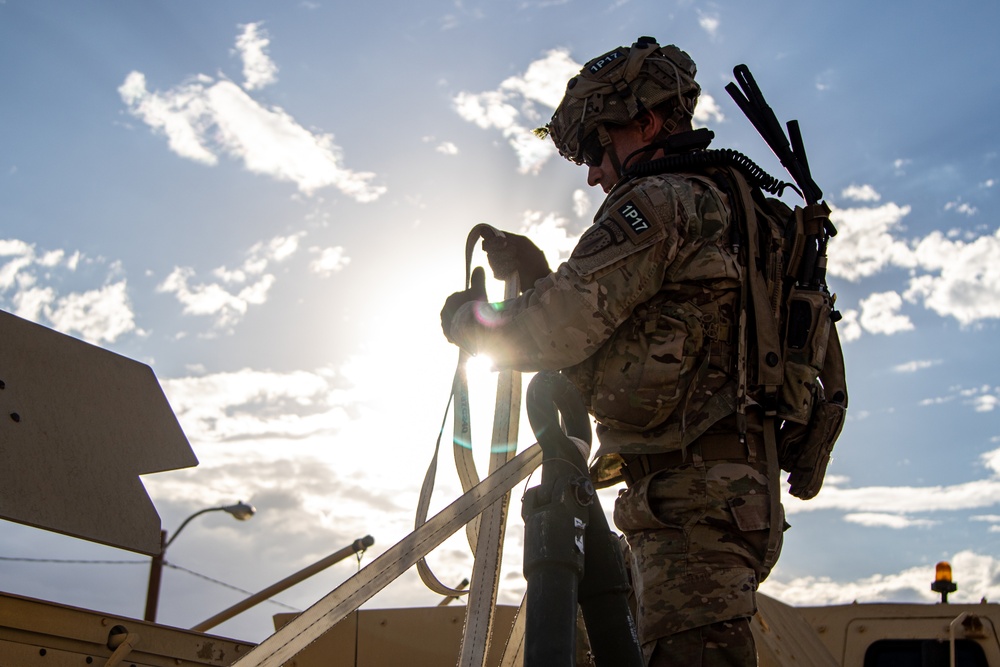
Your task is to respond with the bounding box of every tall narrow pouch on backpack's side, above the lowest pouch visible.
[777,287,834,425]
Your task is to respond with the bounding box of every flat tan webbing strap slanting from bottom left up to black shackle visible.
[233,444,542,667]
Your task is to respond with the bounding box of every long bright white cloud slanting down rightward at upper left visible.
[118,28,386,202]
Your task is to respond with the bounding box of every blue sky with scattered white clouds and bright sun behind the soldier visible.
[0,0,1000,641]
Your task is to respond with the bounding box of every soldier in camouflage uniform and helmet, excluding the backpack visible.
[441,37,783,667]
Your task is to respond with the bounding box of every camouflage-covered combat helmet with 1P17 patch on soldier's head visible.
[537,37,701,171]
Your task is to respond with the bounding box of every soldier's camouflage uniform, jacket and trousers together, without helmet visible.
[450,168,771,665]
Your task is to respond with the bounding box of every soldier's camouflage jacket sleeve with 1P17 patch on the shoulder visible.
[451,175,728,371]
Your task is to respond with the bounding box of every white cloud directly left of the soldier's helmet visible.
[452,49,581,174]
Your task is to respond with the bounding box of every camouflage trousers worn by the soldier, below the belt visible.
[614,433,784,667]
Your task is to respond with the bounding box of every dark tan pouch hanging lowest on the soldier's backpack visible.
[778,398,847,500]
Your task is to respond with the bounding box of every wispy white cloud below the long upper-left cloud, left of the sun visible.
[156,232,304,328]
